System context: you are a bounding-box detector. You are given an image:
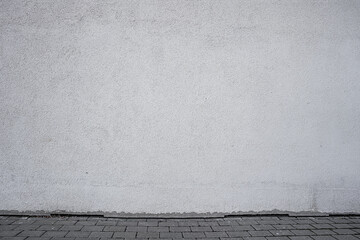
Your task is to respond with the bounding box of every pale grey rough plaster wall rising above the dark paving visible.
[0,0,360,213]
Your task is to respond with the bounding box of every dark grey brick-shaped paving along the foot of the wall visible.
[0,216,360,240]
